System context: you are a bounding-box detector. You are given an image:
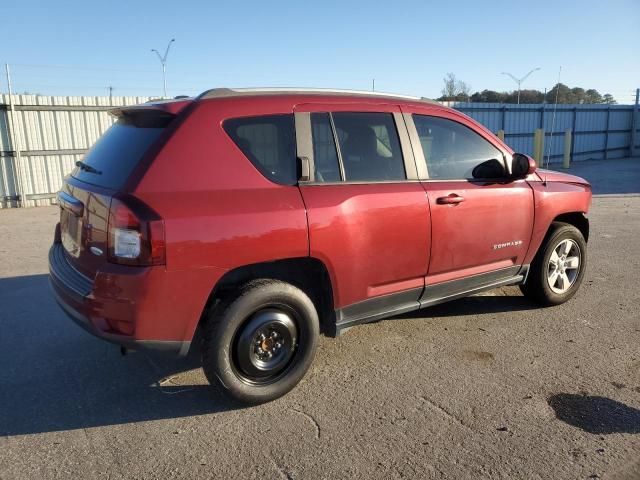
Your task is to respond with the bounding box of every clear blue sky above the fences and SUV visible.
[0,0,640,103]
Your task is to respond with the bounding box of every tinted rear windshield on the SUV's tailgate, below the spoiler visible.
[71,117,170,190]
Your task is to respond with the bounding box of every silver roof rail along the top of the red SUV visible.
[197,87,437,104]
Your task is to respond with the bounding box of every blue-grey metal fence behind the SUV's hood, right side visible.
[444,102,640,163]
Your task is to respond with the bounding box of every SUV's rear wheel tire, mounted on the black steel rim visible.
[202,280,320,404]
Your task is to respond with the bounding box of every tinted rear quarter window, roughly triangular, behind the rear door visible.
[223,115,298,185]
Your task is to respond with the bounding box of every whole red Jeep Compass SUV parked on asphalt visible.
[49,89,591,403]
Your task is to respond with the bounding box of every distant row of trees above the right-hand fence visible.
[438,73,616,105]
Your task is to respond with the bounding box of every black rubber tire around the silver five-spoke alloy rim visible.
[520,222,587,306]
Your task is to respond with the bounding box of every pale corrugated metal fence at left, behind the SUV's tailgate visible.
[0,94,149,208]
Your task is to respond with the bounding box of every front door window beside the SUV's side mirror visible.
[413,114,503,180]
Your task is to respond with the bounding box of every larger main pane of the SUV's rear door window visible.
[332,112,407,182]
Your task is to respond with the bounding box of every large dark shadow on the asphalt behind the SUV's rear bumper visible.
[0,275,243,436]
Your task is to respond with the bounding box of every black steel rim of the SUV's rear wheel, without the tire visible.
[234,307,298,383]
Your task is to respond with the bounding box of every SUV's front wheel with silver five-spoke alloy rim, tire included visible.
[520,222,587,305]
